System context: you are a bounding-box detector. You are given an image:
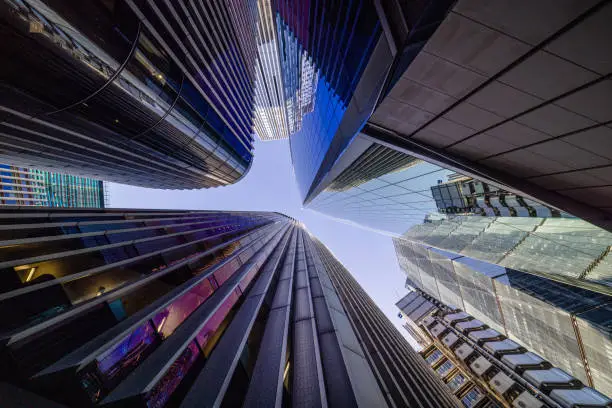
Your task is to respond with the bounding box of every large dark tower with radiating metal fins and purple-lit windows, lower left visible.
[0,208,458,408]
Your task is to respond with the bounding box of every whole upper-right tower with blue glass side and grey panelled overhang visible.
[279,0,612,233]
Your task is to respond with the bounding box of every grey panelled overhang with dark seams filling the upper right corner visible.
[362,0,612,233]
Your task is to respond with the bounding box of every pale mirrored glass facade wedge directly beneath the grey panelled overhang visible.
[294,136,570,234]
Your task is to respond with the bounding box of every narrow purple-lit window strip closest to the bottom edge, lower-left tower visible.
[145,342,200,408]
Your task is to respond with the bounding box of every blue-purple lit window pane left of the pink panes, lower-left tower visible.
[96,322,156,382]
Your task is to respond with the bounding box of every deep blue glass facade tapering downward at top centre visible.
[277,0,382,198]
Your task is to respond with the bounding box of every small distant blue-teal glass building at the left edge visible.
[0,164,108,208]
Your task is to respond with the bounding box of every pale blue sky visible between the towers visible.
[108,140,414,344]
